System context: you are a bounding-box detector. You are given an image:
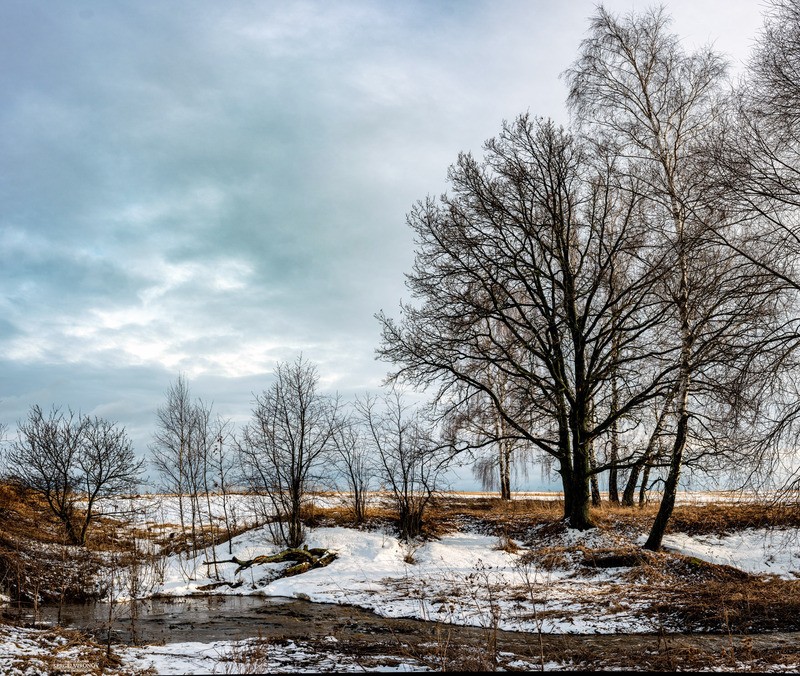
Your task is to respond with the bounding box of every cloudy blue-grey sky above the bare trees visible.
[0,0,763,486]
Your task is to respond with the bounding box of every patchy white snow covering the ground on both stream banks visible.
[0,496,800,674]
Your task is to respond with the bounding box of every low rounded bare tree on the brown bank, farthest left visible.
[6,406,143,545]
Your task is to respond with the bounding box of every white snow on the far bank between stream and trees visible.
[115,516,800,634]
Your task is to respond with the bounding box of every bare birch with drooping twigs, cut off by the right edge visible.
[714,0,800,502]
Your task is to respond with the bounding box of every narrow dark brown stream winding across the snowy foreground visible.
[6,596,798,666]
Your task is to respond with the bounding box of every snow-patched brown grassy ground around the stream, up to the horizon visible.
[0,486,800,674]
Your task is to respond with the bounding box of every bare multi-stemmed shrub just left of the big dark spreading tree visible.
[356,389,445,542]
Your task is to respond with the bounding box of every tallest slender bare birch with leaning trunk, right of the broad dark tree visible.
[566,7,779,549]
